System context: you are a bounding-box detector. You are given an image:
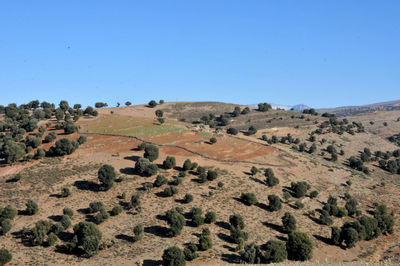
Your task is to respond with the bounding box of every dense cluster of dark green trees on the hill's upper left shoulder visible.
[0,101,94,164]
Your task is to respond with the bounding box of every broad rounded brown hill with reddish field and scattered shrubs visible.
[0,102,400,265]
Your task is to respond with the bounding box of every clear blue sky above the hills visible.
[0,0,400,108]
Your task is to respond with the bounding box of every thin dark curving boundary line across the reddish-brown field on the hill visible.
[80,132,296,167]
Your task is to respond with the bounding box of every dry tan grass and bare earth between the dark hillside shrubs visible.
[0,105,400,265]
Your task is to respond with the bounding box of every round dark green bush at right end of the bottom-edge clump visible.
[286,232,313,261]
